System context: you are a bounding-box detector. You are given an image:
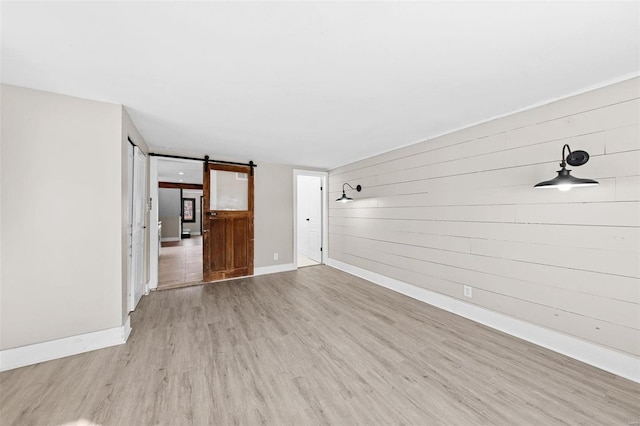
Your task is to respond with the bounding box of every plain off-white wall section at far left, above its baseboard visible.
[0,85,126,349]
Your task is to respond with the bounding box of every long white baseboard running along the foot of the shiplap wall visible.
[327,259,640,383]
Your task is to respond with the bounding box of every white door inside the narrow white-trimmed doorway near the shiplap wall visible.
[297,176,322,263]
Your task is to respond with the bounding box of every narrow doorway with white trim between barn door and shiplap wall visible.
[293,170,327,268]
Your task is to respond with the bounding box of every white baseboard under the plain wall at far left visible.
[0,317,131,371]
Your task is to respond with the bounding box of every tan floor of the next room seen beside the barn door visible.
[158,236,202,290]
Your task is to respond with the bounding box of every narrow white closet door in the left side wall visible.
[130,146,147,310]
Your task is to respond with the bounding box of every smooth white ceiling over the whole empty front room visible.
[1,1,640,168]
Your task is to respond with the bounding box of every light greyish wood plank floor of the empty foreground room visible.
[0,266,640,426]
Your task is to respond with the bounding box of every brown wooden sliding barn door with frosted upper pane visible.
[202,163,253,282]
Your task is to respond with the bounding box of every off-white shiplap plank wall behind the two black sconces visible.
[329,78,640,357]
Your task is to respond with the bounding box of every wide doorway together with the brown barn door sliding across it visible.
[149,153,257,290]
